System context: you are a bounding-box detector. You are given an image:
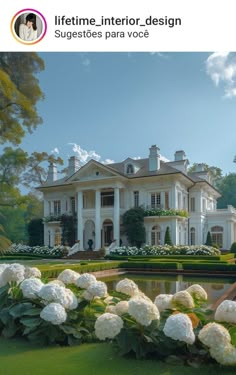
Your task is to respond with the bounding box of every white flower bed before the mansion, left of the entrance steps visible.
[6,244,69,258]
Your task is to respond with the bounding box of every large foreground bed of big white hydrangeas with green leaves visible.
[0,263,236,366]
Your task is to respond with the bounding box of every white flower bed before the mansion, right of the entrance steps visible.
[110,245,220,256]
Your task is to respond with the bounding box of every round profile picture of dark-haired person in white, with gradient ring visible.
[11,9,47,44]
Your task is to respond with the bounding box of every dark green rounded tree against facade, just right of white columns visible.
[123,207,145,247]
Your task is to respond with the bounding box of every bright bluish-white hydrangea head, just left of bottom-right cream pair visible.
[163,313,195,345]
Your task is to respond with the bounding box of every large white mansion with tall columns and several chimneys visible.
[39,145,236,250]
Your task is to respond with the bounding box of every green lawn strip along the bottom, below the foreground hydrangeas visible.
[0,338,236,375]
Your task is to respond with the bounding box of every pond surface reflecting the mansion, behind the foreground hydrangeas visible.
[101,274,235,304]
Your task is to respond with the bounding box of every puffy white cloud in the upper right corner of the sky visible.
[206,52,236,98]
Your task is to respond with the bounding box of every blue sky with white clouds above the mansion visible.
[19,52,236,173]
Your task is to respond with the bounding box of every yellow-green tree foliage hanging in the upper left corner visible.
[0,52,44,145]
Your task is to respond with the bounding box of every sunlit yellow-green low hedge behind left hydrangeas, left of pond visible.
[37,262,121,279]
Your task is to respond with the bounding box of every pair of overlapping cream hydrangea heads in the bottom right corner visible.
[198,323,236,366]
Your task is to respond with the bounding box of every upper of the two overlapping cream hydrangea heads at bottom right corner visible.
[198,323,231,348]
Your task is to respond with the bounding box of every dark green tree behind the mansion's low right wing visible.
[217,173,236,208]
